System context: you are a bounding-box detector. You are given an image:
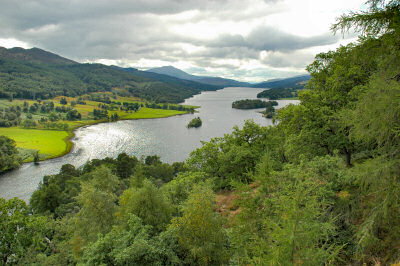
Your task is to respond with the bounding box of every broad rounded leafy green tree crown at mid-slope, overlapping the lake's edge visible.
[188,121,279,189]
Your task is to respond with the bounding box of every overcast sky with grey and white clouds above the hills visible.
[0,0,366,82]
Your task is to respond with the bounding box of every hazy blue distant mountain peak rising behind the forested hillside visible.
[147,66,251,87]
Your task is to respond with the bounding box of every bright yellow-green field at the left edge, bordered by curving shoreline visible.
[0,127,69,159]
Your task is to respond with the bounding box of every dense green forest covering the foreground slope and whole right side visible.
[0,0,400,265]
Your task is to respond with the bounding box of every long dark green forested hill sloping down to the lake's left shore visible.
[0,48,221,103]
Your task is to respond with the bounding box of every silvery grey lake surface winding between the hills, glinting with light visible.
[0,88,298,202]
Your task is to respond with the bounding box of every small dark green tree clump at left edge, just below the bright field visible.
[0,136,21,173]
